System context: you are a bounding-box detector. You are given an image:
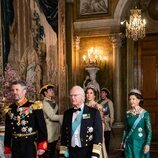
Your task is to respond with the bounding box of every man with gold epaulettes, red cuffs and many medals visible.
[4,81,47,158]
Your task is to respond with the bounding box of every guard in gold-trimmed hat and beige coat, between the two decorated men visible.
[39,84,63,158]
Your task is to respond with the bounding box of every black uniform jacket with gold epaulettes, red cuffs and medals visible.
[4,100,47,153]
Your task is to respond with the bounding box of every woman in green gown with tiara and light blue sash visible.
[121,89,152,158]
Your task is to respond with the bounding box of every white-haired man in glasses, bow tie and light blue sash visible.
[60,86,102,158]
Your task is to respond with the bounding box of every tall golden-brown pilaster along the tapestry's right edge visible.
[57,0,68,113]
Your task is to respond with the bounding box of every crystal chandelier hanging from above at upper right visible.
[126,7,146,41]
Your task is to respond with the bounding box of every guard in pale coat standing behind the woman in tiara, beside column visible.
[98,88,114,153]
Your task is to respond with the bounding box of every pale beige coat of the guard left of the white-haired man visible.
[43,97,63,143]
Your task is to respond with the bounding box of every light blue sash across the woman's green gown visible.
[123,110,146,148]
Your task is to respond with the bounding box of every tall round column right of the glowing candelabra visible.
[110,35,123,128]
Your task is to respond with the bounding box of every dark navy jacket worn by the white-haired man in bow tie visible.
[60,105,103,157]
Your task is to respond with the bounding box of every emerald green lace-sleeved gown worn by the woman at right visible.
[123,111,152,158]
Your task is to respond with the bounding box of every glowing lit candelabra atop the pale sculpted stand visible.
[82,47,107,67]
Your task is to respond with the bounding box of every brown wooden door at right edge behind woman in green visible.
[138,35,158,148]
